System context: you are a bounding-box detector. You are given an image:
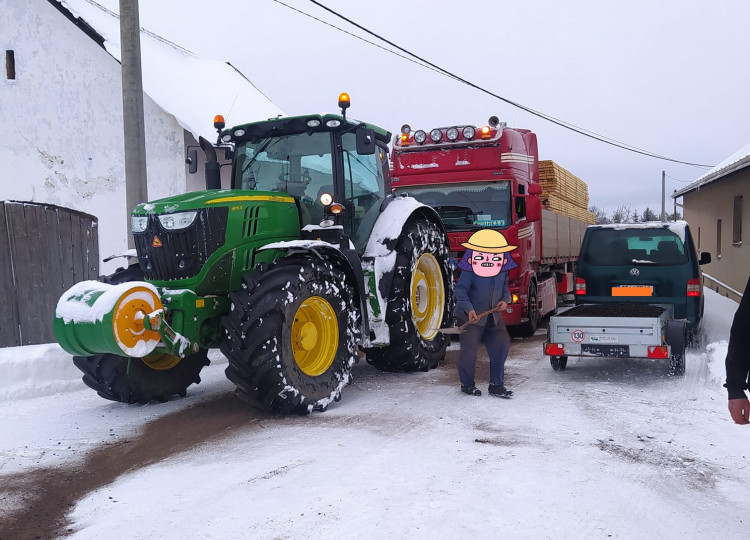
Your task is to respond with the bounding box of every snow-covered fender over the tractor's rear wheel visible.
[362,196,448,345]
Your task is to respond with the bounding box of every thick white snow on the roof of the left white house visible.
[53,0,284,140]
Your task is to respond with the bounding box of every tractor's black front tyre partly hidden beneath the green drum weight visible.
[73,349,210,403]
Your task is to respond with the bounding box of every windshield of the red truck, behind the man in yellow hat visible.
[396,182,511,231]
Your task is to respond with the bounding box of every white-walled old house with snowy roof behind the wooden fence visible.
[0,0,282,273]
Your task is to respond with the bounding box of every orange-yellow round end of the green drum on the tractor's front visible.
[112,285,163,357]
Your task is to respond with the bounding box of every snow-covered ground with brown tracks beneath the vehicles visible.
[0,291,750,540]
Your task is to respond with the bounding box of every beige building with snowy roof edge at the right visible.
[672,144,750,300]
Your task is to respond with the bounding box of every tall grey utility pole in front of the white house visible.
[120,0,148,248]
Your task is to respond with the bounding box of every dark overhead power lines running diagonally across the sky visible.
[302,0,713,168]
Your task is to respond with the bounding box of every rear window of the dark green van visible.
[583,228,688,266]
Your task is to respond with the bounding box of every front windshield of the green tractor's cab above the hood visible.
[233,132,333,224]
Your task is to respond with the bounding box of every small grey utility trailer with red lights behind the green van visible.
[544,302,687,375]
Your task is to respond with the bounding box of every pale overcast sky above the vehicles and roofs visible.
[111,0,750,212]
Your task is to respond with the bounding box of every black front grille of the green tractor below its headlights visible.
[133,208,229,281]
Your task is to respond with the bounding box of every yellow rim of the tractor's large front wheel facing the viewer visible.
[292,296,339,377]
